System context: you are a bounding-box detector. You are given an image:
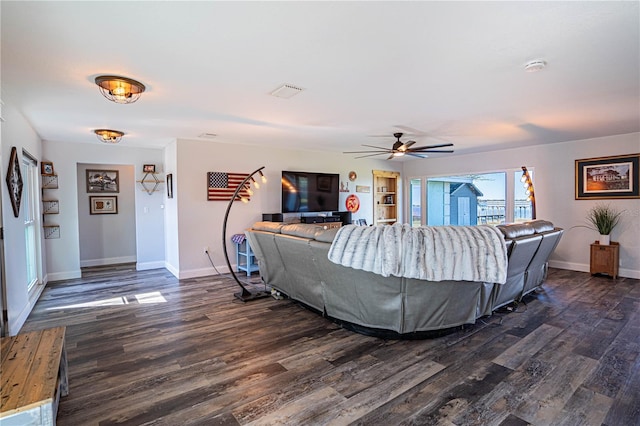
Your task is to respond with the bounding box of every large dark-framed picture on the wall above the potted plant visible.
[575,154,640,200]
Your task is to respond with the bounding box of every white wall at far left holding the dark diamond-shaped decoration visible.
[0,99,46,335]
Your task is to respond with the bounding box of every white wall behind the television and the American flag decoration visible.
[172,139,401,278]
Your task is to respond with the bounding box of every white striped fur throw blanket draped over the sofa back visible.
[328,223,507,284]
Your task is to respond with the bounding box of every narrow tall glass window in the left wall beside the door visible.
[22,151,41,291]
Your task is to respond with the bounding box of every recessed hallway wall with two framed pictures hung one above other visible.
[77,164,139,267]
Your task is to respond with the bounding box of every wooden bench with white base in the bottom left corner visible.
[0,327,69,426]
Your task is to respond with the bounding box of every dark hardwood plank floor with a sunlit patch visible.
[24,265,640,426]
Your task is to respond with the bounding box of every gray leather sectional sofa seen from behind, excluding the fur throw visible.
[246,220,563,338]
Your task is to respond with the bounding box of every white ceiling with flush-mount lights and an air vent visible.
[0,0,640,155]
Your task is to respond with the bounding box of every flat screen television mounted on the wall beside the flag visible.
[282,170,340,213]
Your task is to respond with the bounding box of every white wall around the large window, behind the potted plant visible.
[403,133,640,278]
